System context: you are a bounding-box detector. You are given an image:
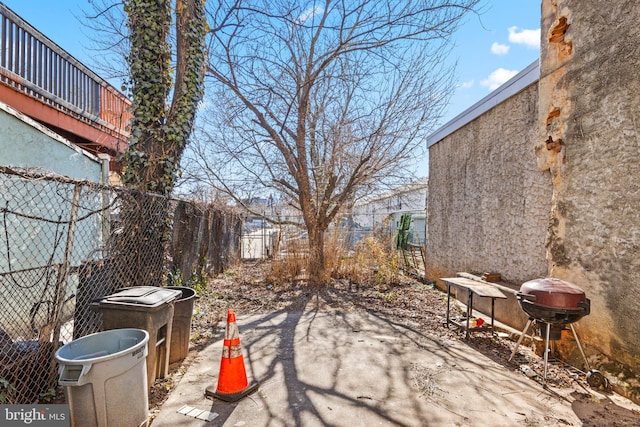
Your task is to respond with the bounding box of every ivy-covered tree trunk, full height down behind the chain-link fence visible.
[118,0,206,286]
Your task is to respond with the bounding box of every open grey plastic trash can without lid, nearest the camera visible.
[56,329,149,427]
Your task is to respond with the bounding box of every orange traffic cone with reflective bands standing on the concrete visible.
[205,310,259,402]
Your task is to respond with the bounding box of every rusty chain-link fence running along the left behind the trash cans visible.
[0,168,241,404]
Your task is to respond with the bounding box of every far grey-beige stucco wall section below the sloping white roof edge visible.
[426,83,551,284]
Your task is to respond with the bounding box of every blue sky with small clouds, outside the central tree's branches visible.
[0,0,541,129]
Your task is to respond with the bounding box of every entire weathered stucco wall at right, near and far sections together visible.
[427,0,640,397]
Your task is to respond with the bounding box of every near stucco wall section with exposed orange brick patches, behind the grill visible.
[535,0,640,372]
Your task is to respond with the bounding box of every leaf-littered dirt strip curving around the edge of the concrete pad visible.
[149,263,640,427]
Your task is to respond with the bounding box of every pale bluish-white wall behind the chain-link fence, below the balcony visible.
[0,103,104,339]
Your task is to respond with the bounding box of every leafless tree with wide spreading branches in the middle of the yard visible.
[182,0,478,283]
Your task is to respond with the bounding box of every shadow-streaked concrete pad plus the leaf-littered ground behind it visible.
[153,276,640,427]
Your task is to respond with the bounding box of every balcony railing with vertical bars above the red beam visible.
[0,3,131,147]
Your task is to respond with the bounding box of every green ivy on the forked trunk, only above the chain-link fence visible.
[122,0,207,195]
